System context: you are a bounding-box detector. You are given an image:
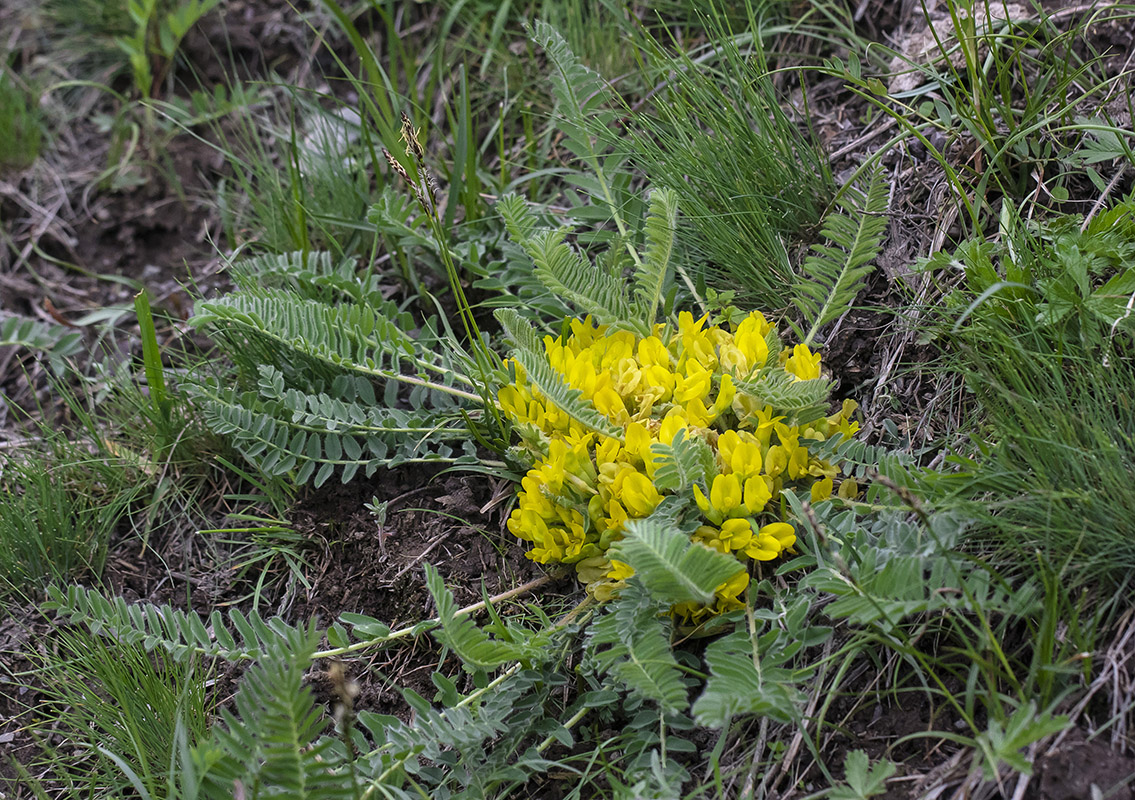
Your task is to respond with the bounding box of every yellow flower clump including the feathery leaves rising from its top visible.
[497,191,858,622]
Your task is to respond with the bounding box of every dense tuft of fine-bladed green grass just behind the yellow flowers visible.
[631,7,834,309]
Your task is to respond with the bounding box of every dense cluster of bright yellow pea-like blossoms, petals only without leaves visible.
[498,312,858,618]
